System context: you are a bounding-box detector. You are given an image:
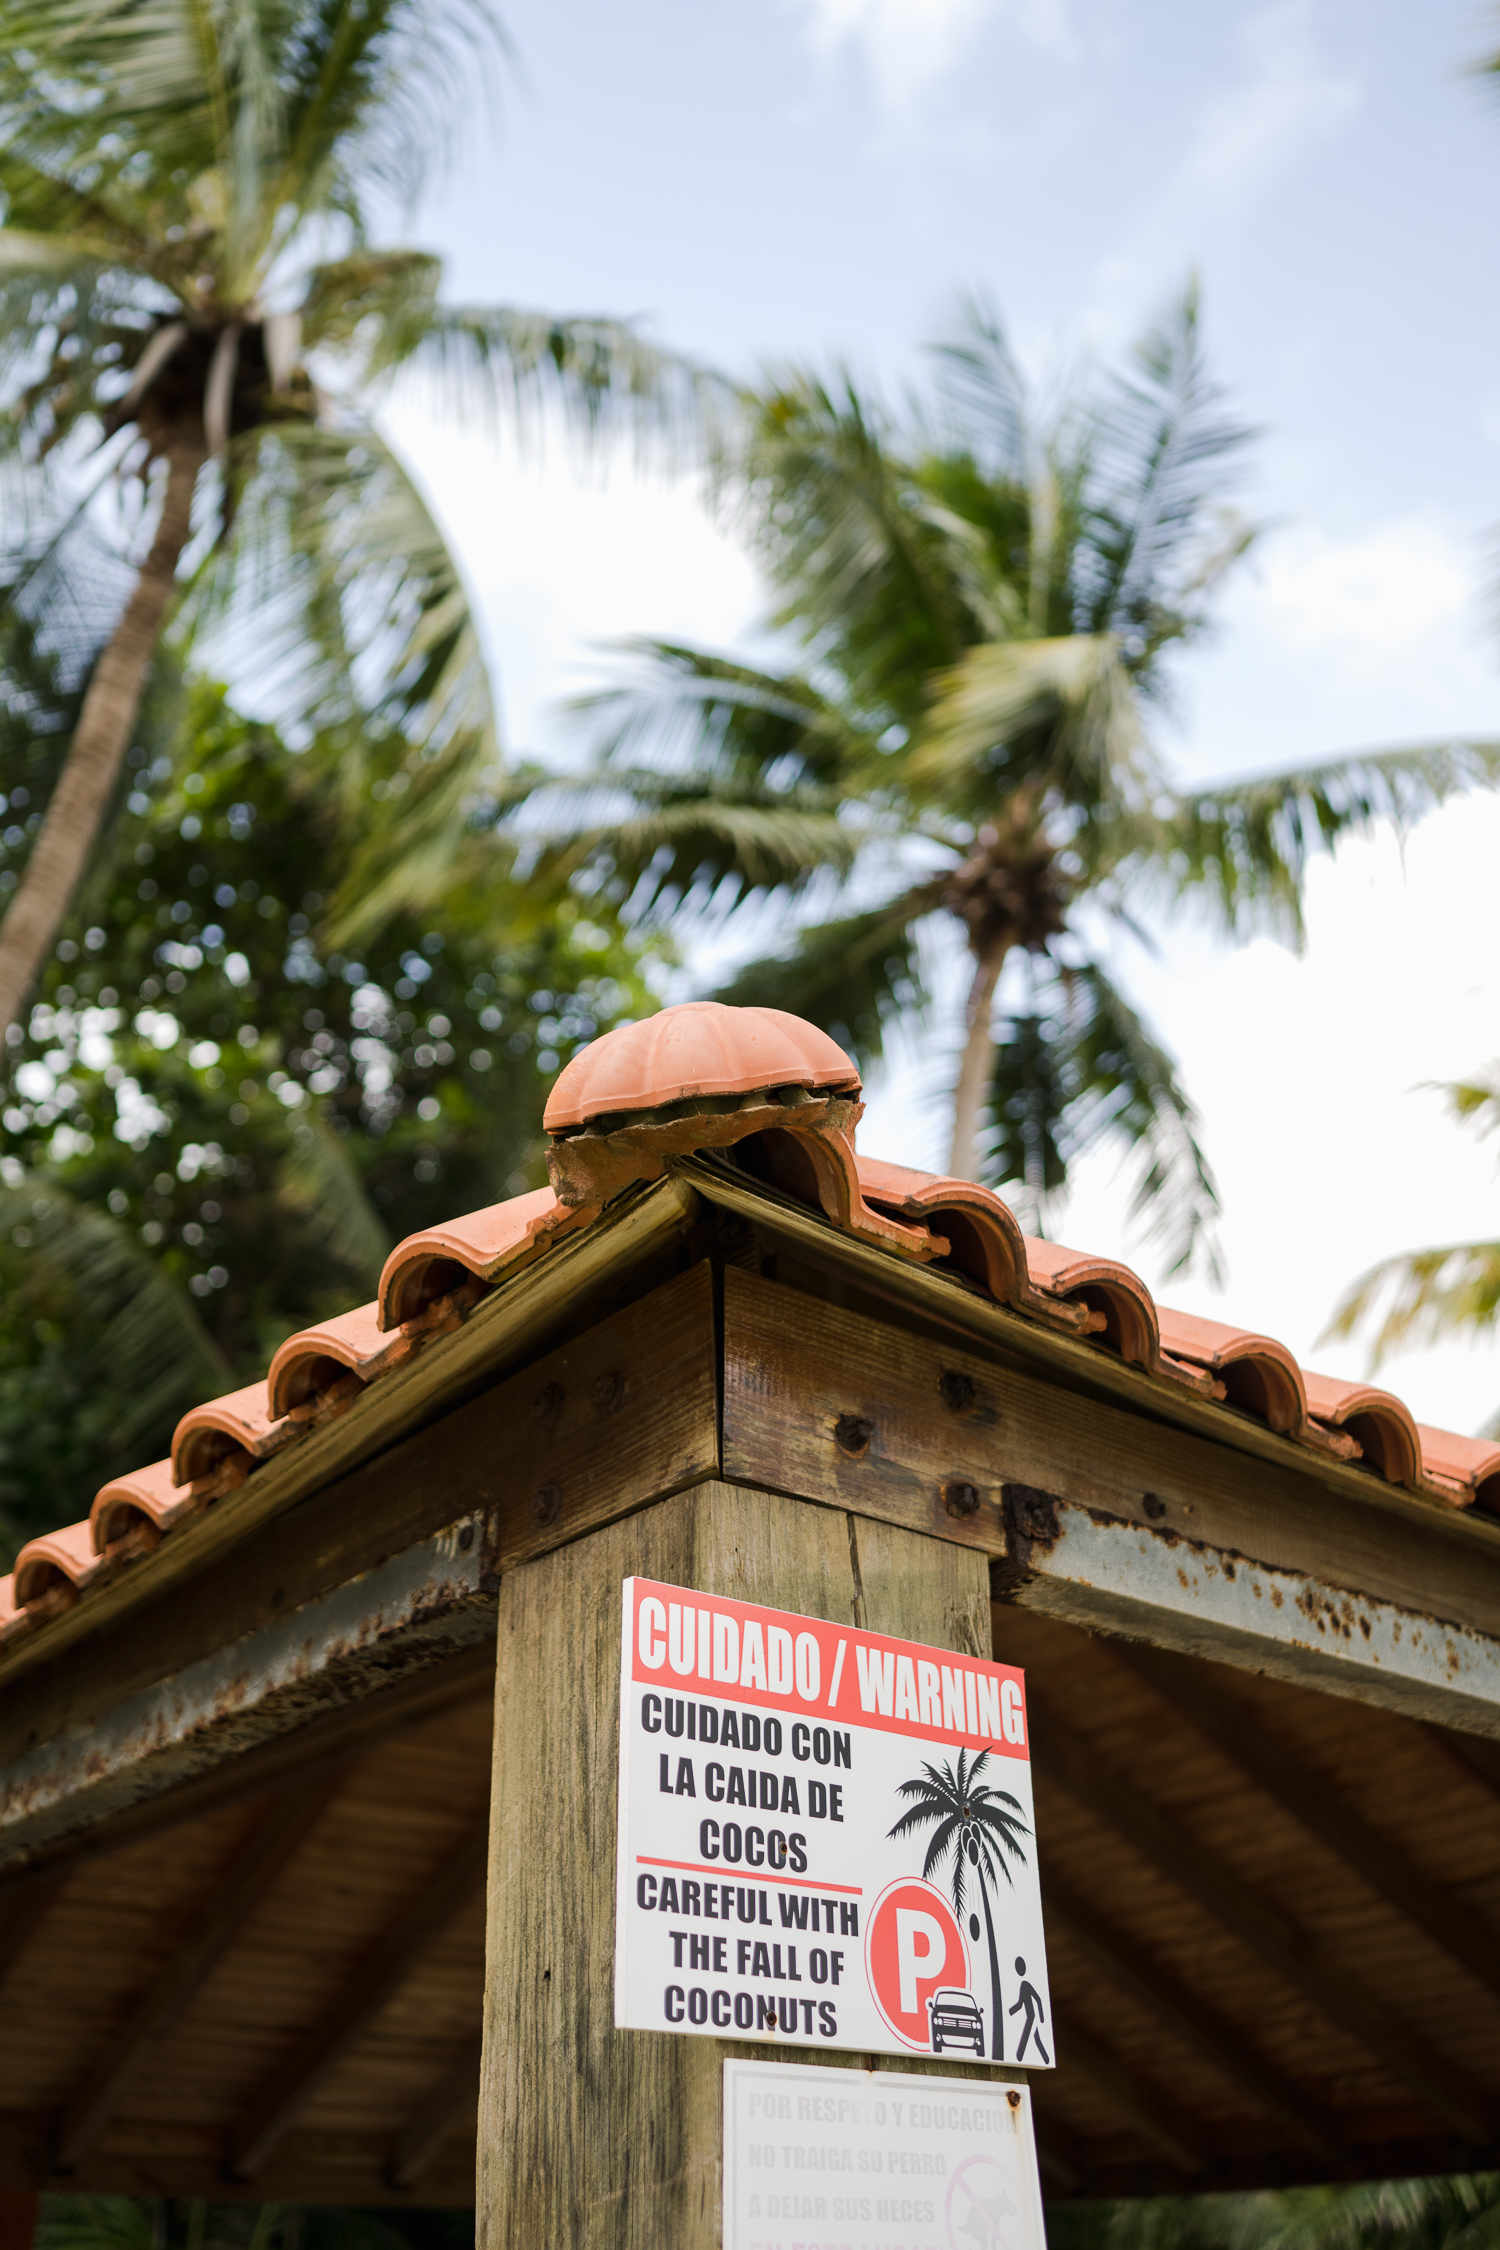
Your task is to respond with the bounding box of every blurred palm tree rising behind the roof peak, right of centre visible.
[551,290,1500,1262]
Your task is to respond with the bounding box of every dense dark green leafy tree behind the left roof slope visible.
[0,684,652,1575]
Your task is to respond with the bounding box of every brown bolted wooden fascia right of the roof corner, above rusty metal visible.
[724,1269,1500,1634]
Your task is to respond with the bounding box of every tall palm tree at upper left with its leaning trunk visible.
[0,0,710,1035]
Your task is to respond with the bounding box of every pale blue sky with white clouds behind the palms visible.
[391,0,1500,1427]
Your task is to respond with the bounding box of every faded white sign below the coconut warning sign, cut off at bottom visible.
[724,2063,1046,2250]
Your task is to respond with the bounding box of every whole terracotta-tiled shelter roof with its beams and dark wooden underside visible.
[0,1012,1500,2203]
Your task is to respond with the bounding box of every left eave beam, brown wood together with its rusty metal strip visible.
[0,1260,717,1856]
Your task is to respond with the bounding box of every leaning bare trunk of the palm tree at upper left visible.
[0,446,202,1040]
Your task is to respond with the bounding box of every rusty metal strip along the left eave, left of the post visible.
[0,1514,497,1865]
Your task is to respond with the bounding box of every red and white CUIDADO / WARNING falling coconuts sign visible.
[614,1577,1055,2070]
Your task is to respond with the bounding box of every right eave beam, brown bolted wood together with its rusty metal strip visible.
[724,1260,1500,1735]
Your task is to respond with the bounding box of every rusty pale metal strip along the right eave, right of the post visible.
[992,1487,1500,1739]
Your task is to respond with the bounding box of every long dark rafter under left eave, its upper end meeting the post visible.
[227,1818,488,2180]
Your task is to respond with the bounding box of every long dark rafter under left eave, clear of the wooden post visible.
[52,1775,333,2174]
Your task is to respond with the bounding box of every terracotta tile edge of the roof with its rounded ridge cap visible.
[0,1001,1500,1638]
